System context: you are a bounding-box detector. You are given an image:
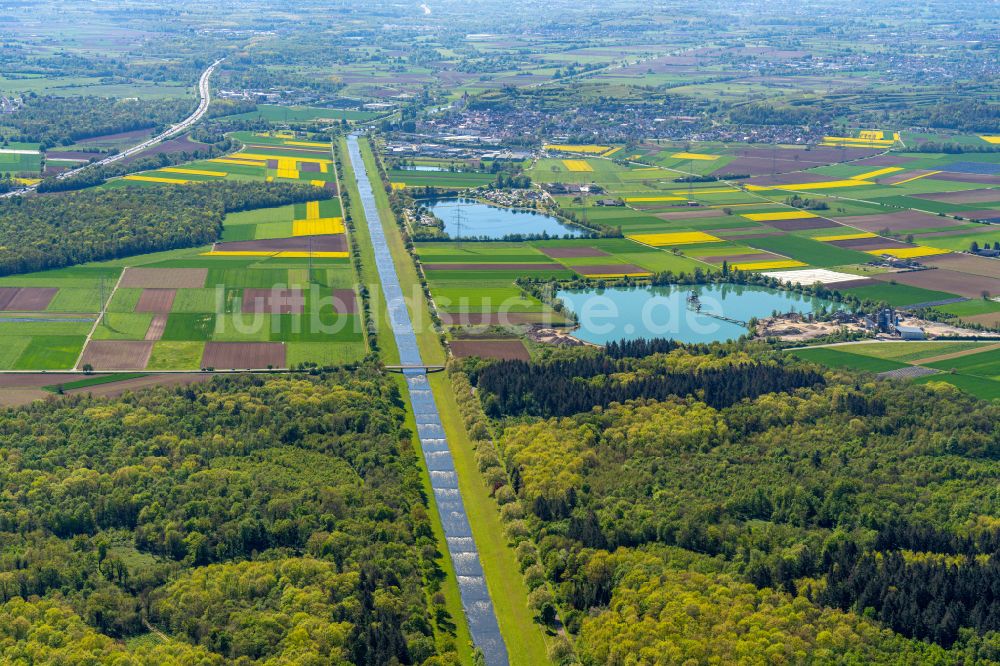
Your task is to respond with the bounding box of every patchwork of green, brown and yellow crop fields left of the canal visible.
[0,135,367,371]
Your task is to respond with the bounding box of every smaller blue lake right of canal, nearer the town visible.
[426,199,584,238]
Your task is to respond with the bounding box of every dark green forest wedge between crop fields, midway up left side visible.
[0,181,329,275]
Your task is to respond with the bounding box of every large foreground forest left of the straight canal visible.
[0,367,457,666]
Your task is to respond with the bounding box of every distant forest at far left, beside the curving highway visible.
[2,94,194,150]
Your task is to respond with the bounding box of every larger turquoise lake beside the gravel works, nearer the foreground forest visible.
[556,284,839,345]
